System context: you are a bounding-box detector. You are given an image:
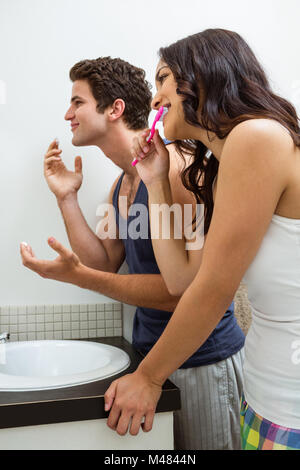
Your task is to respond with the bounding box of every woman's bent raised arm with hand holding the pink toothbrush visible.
[136,135,204,296]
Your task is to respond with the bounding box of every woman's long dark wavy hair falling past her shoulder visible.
[159,29,300,233]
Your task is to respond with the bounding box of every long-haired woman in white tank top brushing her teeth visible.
[105,29,300,449]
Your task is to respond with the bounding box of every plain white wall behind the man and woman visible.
[0,0,300,305]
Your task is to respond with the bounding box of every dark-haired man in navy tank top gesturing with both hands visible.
[21,57,244,449]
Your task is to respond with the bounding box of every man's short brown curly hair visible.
[70,57,152,130]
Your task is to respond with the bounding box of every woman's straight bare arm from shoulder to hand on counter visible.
[105,120,289,434]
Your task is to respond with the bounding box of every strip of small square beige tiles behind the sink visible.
[0,302,123,341]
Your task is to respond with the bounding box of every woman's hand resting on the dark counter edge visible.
[104,370,162,436]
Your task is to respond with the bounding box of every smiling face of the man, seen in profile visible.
[65,80,107,146]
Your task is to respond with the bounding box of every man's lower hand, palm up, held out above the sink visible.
[20,237,83,284]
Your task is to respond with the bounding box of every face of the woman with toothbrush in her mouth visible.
[151,60,190,140]
